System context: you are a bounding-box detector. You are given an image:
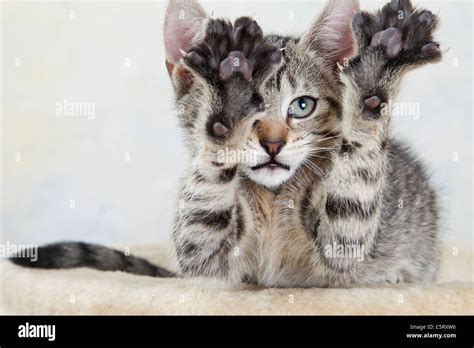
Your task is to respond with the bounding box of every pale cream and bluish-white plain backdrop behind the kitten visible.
[0,1,473,245]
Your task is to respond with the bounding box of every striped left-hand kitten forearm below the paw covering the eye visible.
[173,147,248,278]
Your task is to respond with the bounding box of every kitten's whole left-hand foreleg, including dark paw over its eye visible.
[173,17,282,281]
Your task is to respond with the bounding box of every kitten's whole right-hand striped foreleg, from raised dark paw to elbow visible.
[317,0,441,275]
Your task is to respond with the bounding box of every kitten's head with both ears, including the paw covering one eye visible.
[165,0,358,189]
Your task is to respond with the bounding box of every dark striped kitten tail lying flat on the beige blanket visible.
[9,242,176,278]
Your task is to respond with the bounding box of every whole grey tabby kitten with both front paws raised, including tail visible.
[12,0,441,287]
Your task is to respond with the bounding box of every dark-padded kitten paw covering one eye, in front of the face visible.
[182,17,283,144]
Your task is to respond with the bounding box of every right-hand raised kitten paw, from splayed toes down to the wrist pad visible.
[341,0,441,118]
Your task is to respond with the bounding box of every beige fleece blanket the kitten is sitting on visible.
[0,243,474,314]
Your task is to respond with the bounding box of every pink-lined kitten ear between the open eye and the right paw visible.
[302,0,359,66]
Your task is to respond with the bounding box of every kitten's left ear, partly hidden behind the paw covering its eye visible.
[163,0,208,76]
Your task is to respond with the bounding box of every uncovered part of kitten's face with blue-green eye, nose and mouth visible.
[244,42,340,188]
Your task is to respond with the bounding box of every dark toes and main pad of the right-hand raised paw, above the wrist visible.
[353,0,441,65]
